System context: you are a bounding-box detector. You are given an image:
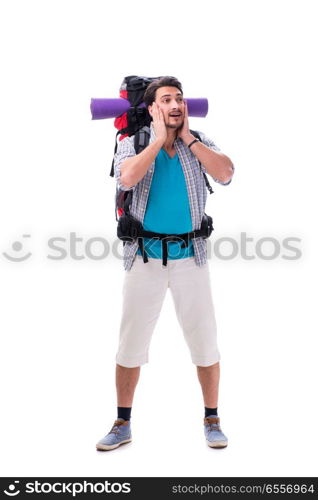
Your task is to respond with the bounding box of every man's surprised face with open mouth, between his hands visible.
[148,87,184,129]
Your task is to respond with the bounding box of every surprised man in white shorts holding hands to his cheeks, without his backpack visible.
[96,77,234,450]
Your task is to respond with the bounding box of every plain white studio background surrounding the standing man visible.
[0,0,318,477]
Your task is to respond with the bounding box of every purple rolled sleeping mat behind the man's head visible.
[91,97,209,120]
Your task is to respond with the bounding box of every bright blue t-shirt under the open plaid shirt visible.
[137,149,194,260]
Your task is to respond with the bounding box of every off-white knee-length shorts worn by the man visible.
[116,255,220,368]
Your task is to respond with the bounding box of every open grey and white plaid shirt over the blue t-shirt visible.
[114,122,231,271]
